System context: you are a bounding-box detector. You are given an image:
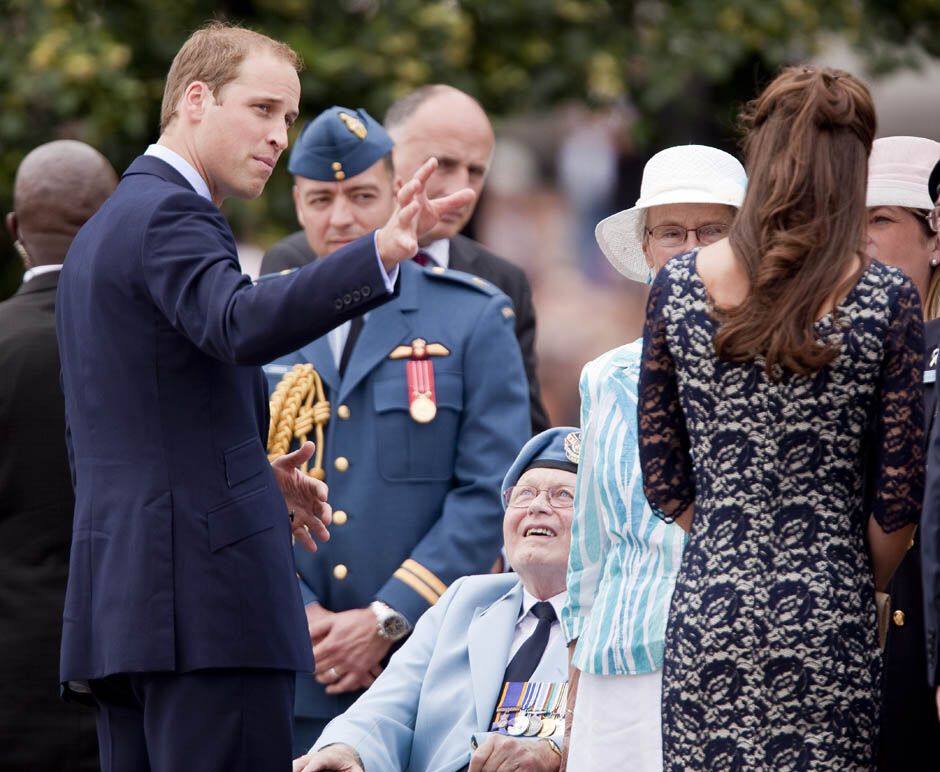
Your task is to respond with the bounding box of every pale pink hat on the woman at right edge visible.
[865,137,940,209]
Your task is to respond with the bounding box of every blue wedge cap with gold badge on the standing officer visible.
[287,107,394,182]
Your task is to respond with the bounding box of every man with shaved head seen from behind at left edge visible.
[0,140,117,770]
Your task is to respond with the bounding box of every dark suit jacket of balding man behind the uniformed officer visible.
[261,231,551,433]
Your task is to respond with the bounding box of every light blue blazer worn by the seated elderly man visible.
[314,574,568,772]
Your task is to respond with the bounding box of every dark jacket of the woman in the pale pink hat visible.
[878,319,940,772]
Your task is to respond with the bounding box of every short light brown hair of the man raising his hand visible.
[160,21,303,133]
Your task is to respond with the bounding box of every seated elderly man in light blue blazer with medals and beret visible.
[294,427,580,772]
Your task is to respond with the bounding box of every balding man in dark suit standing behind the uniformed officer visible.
[261,85,549,432]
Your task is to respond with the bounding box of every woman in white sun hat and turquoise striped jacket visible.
[562,145,746,772]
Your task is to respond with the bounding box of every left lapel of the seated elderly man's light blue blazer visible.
[467,582,522,731]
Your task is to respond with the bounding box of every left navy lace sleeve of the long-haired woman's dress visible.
[637,269,695,523]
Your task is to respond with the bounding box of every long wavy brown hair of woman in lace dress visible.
[714,67,875,375]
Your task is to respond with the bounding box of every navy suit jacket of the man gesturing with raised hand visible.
[56,156,391,681]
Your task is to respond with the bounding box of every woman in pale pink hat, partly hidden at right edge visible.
[866,137,940,772]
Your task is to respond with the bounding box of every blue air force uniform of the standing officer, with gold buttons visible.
[265,263,530,736]
